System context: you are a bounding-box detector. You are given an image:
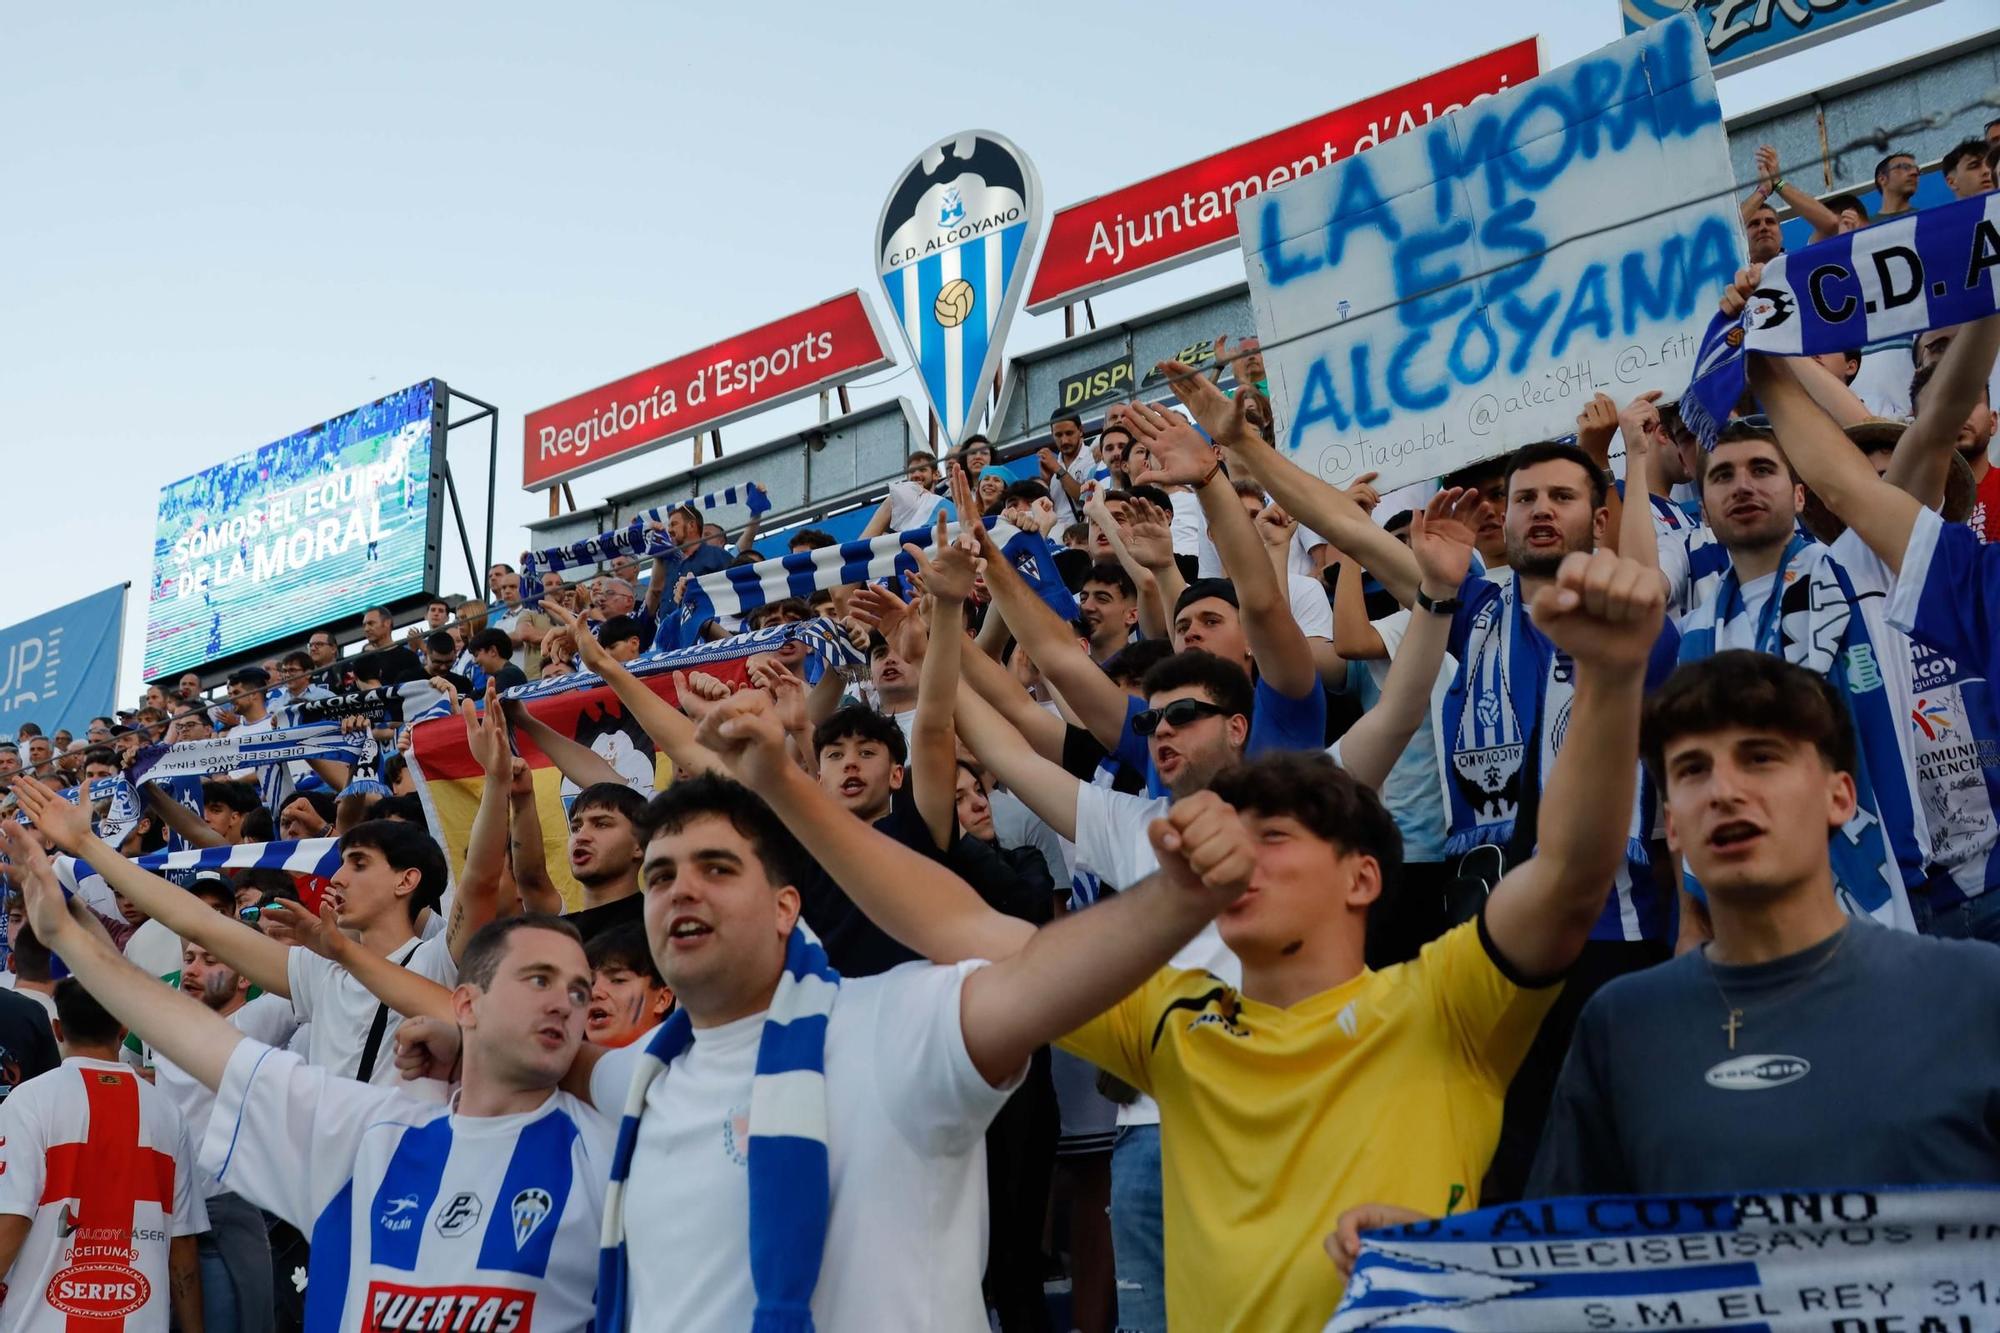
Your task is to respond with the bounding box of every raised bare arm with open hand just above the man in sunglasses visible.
[1124,402,1320,699]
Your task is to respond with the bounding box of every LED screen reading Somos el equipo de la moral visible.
[146,380,444,681]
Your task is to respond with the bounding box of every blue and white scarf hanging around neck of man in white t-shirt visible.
[596,923,840,1333]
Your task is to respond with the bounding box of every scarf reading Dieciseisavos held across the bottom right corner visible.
[1326,1185,2000,1333]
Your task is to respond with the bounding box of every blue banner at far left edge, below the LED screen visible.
[0,584,128,739]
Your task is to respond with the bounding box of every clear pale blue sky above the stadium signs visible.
[0,0,1994,703]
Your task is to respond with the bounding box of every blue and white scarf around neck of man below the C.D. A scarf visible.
[1680,536,1924,931]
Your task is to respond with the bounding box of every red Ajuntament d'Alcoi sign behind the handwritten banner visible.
[1028,38,1542,314]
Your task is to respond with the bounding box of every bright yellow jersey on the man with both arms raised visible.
[1060,921,1560,1333]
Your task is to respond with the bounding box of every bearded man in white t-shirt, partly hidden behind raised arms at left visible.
[152,875,298,1333]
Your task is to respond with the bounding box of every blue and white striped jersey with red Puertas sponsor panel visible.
[202,1041,612,1333]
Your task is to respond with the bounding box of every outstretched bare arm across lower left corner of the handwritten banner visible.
[1158,360,1420,606]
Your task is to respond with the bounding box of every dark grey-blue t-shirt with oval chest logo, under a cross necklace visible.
[1528,923,2000,1197]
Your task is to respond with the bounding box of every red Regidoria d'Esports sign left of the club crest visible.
[520,292,896,490]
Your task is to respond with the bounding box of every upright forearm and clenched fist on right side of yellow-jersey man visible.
[1486,550,1666,979]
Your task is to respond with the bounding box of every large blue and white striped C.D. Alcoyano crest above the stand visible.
[876,130,1042,448]
